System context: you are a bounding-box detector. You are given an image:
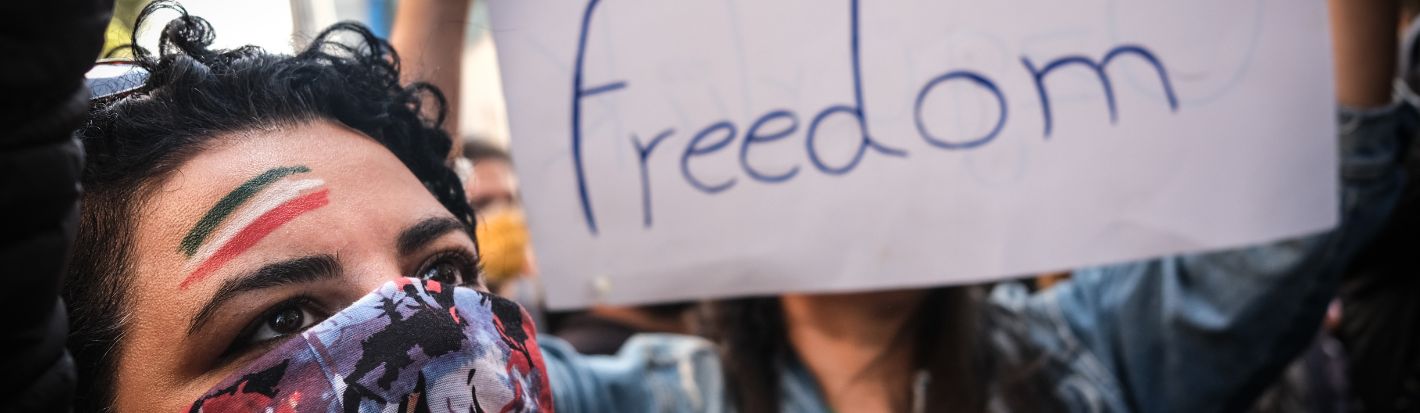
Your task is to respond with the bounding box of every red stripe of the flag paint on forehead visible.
[178,189,331,290]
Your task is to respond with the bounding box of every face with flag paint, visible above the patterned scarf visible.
[114,121,477,412]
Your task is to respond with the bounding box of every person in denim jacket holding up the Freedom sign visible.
[542,0,1414,413]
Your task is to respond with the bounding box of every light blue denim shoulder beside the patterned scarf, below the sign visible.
[538,334,726,413]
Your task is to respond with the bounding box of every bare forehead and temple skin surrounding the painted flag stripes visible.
[116,121,447,410]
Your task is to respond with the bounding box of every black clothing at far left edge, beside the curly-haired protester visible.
[0,0,114,412]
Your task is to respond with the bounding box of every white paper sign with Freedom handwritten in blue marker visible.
[490,0,1336,308]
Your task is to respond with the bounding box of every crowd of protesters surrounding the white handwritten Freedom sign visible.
[0,0,1420,413]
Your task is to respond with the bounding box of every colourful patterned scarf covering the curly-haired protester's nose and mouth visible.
[189,278,552,413]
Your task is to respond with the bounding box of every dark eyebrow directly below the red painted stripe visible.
[187,255,341,336]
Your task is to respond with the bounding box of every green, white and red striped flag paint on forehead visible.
[178,166,329,290]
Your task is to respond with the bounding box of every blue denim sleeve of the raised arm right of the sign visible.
[1028,105,1413,412]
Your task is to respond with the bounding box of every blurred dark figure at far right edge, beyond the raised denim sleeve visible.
[1255,0,1420,412]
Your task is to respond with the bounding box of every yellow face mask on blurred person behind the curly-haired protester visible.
[476,209,531,291]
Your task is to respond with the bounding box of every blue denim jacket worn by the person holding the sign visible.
[540,105,1414,413]
